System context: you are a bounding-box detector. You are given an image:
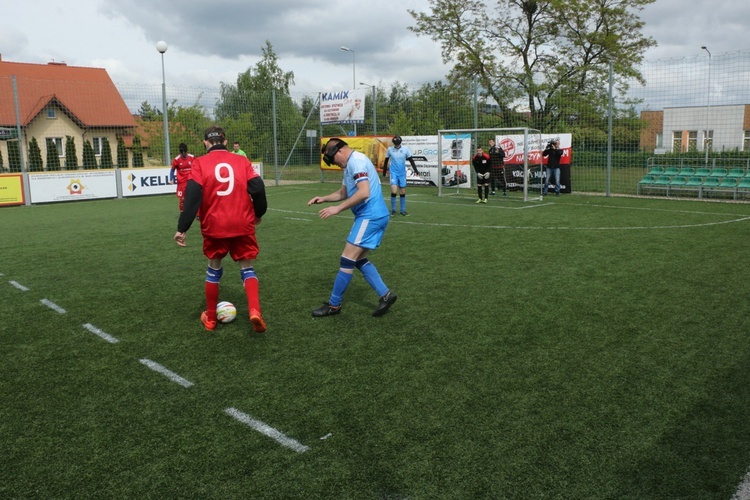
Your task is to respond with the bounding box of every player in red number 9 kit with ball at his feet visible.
[174,125,268,333]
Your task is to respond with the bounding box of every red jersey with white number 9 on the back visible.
[189,149,259,238]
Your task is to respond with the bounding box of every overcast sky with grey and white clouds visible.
[0,0,750,101]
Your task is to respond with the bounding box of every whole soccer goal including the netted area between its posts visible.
[437,128,545,201]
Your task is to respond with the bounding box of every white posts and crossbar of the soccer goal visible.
[437,127,544,201]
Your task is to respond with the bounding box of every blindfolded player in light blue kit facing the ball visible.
[307,137,397,317]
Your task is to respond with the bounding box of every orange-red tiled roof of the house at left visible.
[0,59,135,128]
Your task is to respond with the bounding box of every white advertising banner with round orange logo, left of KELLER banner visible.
[29,170,117,203]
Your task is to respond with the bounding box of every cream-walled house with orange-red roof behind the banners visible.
[0,56,136,170]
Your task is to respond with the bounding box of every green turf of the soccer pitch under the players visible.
[0,186,750,499]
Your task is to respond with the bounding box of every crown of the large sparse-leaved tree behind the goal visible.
[409,0,656,129]
